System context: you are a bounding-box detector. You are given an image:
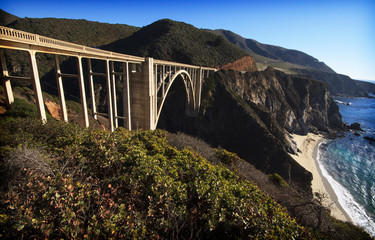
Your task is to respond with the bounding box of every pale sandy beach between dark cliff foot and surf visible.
[291,133,351,221]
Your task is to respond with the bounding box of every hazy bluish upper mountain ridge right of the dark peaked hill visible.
[208,29,334,73]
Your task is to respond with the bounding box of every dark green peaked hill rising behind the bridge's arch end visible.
[102,19,248,66]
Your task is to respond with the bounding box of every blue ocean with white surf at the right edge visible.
[318,98,375,236]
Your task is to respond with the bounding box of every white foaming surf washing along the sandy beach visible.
[317,143,375,237]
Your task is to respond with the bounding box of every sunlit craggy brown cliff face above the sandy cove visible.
[225,68,343,134]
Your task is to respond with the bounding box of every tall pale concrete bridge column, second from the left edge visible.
[29,50,47,123]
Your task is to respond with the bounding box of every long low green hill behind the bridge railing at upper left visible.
[9,18,139,47]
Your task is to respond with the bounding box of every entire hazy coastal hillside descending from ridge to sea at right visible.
[212,30,371,97]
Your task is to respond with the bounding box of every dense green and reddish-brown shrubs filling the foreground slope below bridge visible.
[0,118,309,239]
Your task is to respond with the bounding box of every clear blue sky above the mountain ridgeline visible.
[0,0,375,80]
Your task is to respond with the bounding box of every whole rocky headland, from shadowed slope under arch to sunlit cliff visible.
[158,68,342,193]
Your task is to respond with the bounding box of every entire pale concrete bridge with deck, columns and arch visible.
[0,26,216,131]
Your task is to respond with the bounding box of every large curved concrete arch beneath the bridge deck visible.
[155,70,196,126]
